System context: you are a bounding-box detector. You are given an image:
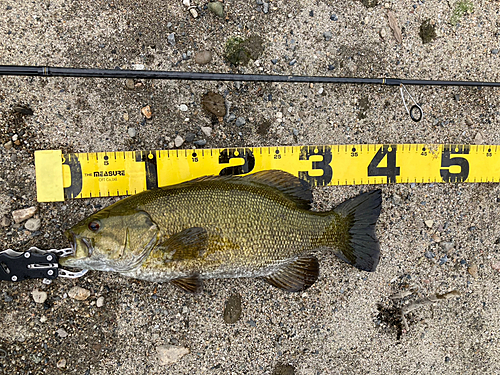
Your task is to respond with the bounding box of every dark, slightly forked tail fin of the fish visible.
[321,189,382,272]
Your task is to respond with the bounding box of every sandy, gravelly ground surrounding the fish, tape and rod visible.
[0,0,500,375]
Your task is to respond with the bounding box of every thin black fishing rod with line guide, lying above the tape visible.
[0,65,500,122]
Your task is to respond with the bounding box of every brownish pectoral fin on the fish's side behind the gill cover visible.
[159,227,208,261]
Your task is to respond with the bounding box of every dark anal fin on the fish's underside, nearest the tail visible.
[263,255,319,292]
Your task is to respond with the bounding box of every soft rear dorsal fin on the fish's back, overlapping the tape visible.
[240,169,312,210]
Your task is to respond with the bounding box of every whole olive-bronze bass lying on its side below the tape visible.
[60,170,382,293]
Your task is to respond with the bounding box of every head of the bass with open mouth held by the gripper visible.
[59,206,159,272]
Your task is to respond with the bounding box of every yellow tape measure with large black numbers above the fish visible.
[35,144,500,202]
